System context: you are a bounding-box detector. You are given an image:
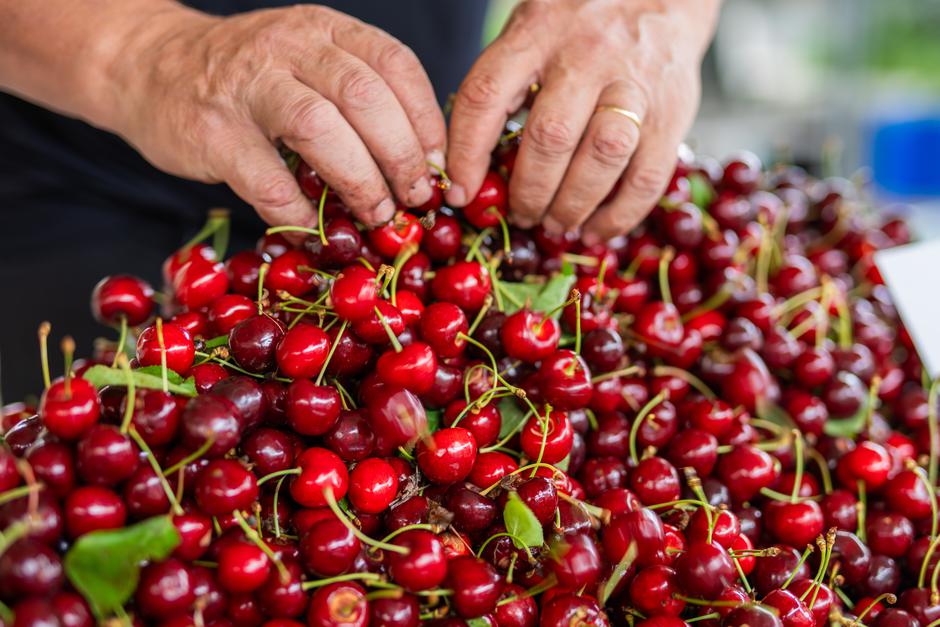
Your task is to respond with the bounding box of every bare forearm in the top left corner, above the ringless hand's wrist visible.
[0,0,202,130]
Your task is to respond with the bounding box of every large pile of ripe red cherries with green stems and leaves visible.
[0,139,940,627]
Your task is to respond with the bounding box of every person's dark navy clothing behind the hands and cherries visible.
[0,0,487,402]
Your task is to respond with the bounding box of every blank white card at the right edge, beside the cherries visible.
[875,239,940,379]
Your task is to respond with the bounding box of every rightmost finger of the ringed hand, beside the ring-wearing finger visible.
[583,129,681,244]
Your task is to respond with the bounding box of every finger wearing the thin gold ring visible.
[542,81,646,233]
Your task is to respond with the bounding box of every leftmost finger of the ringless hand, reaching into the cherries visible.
[217,127,317,227]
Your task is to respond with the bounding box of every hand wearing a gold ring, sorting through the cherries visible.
[447,0,718,243]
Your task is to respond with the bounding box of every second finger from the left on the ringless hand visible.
[252,76,395,226]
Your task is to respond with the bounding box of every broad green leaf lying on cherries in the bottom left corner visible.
[64,516,180,619]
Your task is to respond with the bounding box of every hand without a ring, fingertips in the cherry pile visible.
[106,3,446,227]
